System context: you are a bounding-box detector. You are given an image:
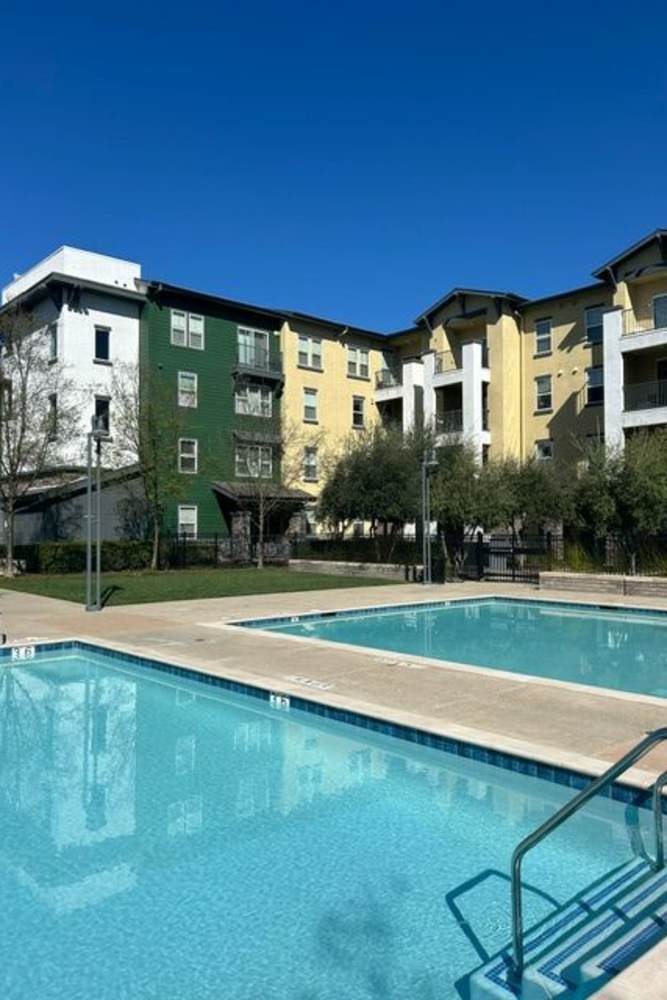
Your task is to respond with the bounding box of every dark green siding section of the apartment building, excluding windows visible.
[140,290,282,536]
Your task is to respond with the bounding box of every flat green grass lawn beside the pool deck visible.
[0,566,391,605]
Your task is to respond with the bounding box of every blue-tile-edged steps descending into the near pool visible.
[470,858,667,1000]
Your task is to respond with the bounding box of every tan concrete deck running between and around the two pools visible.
[0,583,667,1000]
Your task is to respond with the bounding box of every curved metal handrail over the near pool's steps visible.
[512,726,667,976]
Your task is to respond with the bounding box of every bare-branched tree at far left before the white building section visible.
[0,308,78,576]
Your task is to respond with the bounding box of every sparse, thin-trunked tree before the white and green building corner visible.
[112,363,184,569]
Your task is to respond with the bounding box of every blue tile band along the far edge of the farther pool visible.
[226,594,667,629]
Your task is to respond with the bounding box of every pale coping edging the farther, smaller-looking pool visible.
[223,594,667,709]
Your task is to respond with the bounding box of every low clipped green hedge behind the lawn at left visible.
[0,541,151,574]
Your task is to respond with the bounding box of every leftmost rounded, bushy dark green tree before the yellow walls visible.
[318,424,421,560]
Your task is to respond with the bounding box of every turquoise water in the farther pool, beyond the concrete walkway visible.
[247,598,667,697]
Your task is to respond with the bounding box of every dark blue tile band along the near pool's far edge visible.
[5,636,667,815]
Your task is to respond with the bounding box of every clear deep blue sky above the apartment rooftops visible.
[0,0,667,330]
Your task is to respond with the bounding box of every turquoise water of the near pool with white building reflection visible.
[0,651,651,1000]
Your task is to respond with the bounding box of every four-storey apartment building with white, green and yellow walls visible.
[1,230,667,536]
